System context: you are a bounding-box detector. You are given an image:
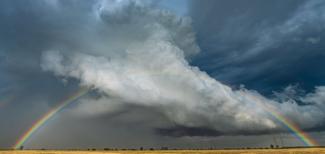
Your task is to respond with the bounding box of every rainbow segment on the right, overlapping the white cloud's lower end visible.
[248,94,319,147]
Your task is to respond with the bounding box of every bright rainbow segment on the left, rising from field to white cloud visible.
[13,88,88,149]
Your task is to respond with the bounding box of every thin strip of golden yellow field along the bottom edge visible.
[0,148,325,154]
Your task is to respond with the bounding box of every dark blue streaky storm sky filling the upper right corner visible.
[190,0,325,94]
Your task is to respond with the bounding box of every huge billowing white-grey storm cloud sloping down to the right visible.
[41,0,325,134]
